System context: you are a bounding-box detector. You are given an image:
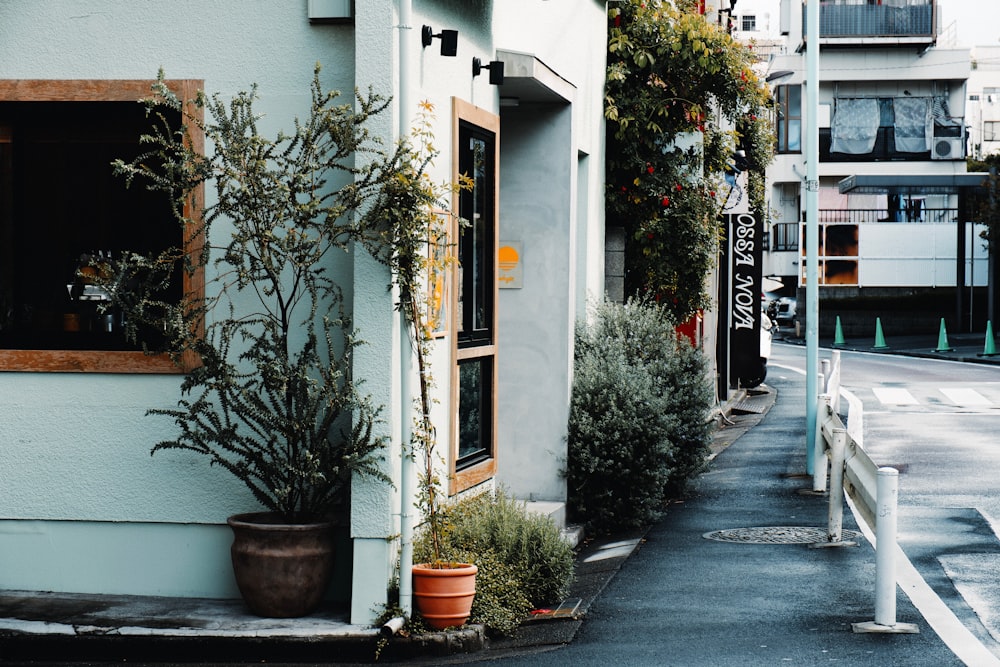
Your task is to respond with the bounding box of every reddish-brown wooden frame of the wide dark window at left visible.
[0,79,205,374]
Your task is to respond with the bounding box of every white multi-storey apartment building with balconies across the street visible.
[768,0,986,335]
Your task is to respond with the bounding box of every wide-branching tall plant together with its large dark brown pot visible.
[98,66,405,617]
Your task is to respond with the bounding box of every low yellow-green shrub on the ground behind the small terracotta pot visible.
[413,491,574,634]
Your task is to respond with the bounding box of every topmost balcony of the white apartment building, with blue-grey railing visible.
[802,0,937,47]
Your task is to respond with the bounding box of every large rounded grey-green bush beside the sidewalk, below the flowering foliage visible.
[565,300,712,532]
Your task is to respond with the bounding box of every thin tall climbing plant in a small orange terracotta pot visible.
[367,102,478,629]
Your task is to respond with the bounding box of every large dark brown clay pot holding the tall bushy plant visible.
[227,512,334,618]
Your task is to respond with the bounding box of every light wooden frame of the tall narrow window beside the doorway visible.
[448,97,500,495]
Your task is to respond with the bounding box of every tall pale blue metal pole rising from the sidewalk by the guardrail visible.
[803,0,820,474]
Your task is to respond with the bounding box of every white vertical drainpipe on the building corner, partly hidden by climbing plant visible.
[394,0,415,616]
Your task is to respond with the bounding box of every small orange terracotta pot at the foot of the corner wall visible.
[413,563,479,630]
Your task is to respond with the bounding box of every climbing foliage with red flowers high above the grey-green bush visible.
[605,0,773,321]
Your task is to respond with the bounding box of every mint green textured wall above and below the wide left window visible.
[0,0,366,597]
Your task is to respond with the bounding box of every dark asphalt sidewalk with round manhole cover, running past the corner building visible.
[0,350,984,667]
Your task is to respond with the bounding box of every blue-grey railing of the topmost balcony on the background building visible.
[802,0,934,39]
